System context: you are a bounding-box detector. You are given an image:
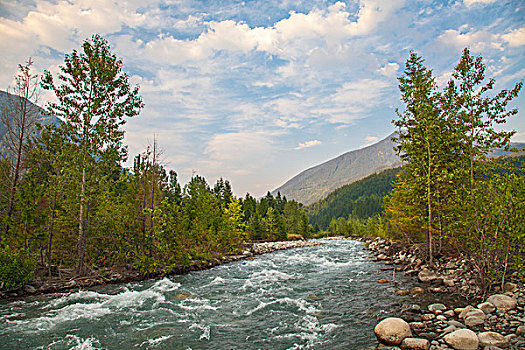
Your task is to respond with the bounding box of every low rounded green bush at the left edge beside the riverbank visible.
[0,247,35,290]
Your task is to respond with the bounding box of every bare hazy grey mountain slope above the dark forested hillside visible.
[272,134,401,205]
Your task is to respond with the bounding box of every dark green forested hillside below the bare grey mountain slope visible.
[306,167,401,230]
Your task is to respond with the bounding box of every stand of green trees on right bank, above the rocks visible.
[385,49,525,289]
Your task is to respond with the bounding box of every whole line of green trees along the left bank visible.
[0,36,309,289]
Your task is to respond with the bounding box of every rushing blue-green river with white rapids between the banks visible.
[0,241,418,349]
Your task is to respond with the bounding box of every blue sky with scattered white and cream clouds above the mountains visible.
[0,0,525,196]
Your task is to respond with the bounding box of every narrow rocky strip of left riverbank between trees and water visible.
[0,240,323,299]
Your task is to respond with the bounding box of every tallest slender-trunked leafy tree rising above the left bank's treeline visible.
[42,35,143,273]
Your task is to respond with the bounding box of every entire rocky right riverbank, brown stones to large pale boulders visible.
[359,238,525,350]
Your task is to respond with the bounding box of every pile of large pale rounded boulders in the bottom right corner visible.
[375,290,525,350]
